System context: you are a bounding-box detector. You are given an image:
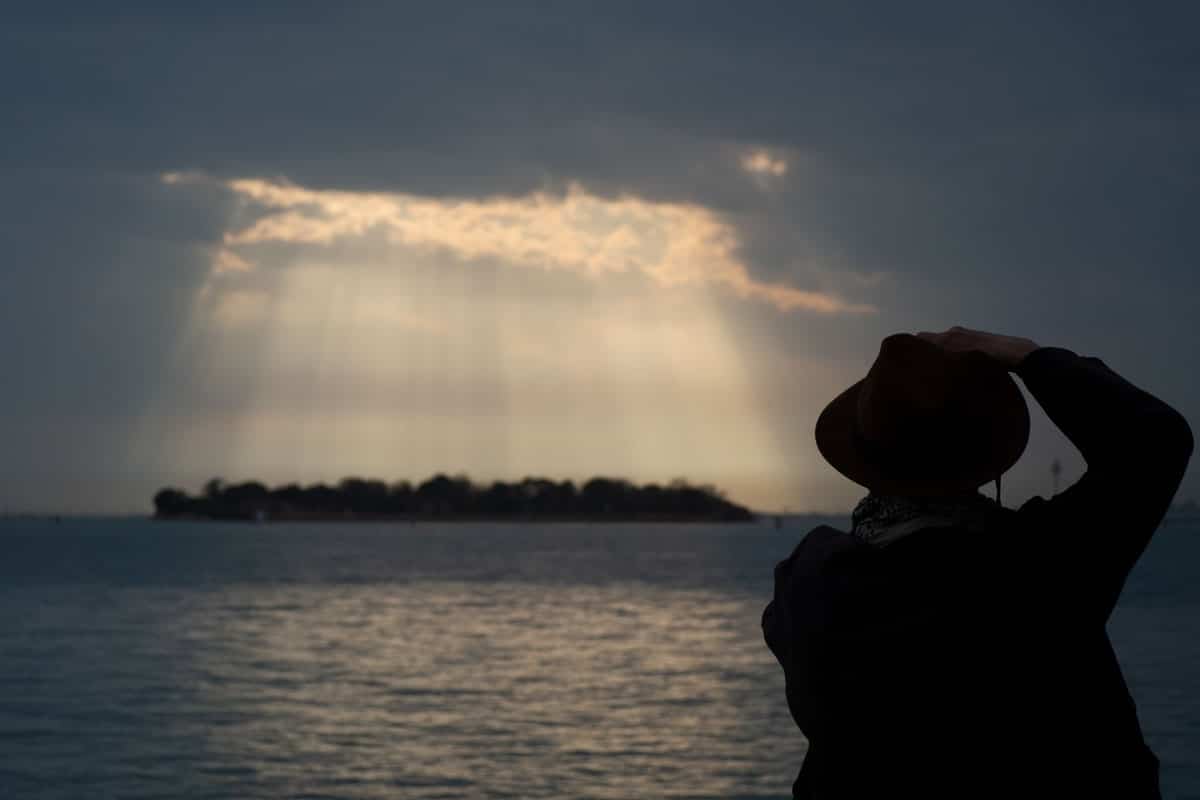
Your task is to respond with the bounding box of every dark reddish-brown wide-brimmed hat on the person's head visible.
[816,333,1030,495]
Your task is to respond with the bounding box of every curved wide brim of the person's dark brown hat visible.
[816,378,1030,497]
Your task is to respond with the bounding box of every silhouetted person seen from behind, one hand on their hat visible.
[763,327,1193,800]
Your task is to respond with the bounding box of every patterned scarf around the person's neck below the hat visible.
[850,492,1000,547]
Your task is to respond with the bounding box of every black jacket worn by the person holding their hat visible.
[763,348,1193,800]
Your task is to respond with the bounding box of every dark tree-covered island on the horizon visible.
[154,474,754,522]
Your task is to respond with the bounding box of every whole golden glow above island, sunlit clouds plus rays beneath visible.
[150,178,844,503]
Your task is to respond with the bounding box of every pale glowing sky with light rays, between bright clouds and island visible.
[143,251,787,503]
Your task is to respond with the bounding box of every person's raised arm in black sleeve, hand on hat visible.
[924,329,1194,618]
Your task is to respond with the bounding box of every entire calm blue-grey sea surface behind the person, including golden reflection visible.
[0,518,1200,800]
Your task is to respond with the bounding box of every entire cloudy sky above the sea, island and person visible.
[0,0,1200,513]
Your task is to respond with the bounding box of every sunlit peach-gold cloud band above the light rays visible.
[163,173,874,313]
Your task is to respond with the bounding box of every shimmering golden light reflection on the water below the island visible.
[181,583,802,798]
